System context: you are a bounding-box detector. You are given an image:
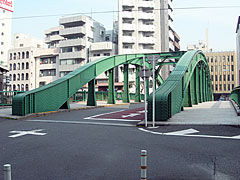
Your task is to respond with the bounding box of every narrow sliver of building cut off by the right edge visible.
[236,16,240,86]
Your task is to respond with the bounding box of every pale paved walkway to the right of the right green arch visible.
[158,101,240,125]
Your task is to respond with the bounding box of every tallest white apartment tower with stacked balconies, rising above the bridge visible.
[118,0,178,54]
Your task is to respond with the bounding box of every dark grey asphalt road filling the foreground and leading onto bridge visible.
[0,104,240,180]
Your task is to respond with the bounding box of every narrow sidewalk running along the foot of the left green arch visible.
[0,101,134,120]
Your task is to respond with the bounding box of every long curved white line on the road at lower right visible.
[138,128,240,140]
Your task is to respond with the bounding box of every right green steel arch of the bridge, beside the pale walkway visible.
[148,50,213,121]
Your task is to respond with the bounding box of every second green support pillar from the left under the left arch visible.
[107,68,116,104]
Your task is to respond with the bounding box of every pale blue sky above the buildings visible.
[7,0,240,51]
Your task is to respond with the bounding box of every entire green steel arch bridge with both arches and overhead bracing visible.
[12,51,213,121]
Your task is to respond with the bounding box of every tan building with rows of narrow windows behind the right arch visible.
[206,51,238,100]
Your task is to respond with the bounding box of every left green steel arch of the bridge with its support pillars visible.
[12,52,185,116]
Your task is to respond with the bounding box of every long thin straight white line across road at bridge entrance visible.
[26,120,136,127]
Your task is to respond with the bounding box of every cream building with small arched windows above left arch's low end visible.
[8,34,58,91]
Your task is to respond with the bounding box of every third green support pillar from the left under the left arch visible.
[123,64,130,103]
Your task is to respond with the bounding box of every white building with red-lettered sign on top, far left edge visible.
[0,0,14,66]
